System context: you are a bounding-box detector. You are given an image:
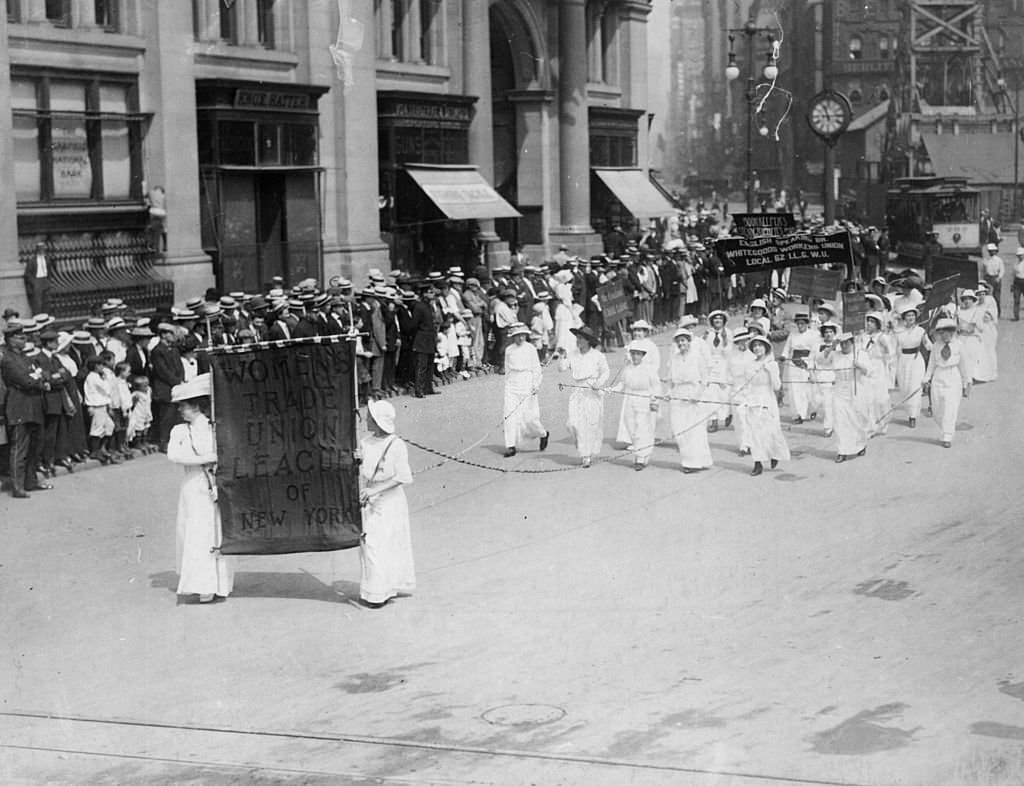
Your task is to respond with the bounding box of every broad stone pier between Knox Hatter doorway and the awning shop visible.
[306,0,390,286]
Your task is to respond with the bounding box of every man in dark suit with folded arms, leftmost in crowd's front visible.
[0,320,53,499]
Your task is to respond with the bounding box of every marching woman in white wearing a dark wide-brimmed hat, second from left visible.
[558,325,610,467]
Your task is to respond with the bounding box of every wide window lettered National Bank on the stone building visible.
[11,71,143,202]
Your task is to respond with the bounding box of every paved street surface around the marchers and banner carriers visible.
[0,315,1024,786]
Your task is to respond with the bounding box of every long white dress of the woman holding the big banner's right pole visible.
[359,435,416,603]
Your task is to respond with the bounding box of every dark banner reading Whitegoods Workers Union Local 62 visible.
[715,231,852,273]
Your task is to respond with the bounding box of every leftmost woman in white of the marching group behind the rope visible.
[503,322,548,459]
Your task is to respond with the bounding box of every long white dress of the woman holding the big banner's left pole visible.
[167,414,234,598]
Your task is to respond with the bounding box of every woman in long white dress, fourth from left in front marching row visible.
[669,328,713,475]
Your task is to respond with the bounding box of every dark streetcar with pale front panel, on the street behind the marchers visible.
[886,176,981,281]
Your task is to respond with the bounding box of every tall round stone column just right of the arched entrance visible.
[551,0,600,256]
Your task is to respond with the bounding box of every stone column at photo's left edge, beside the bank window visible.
[0,14,29,316]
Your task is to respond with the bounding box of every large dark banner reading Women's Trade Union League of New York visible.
[210,339,362,554]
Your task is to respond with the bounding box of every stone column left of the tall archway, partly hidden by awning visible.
[462,0,509,268]
